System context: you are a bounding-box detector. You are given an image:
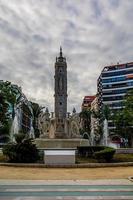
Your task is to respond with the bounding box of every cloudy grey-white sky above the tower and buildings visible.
[0,0,133,112]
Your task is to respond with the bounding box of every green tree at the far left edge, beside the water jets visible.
[0,81,16,142]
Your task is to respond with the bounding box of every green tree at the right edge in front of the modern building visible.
[113,90,133,146]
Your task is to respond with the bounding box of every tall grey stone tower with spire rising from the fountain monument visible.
[54,47,67,138]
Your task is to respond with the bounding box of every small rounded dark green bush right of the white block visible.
[94,147,115,162]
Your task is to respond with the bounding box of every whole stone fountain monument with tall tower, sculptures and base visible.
[35,48,88,148]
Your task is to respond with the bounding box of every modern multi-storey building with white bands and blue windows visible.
[97,62,133,132]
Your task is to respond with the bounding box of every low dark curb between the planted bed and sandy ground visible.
[0,162,133,168]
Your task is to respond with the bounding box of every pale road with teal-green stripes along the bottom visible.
[0,179,133,200]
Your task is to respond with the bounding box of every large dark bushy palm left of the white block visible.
[3,133,39,163]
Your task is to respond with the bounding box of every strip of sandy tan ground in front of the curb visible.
[0,166,133,180]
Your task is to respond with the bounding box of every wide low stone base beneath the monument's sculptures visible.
[35,138,89,149]
